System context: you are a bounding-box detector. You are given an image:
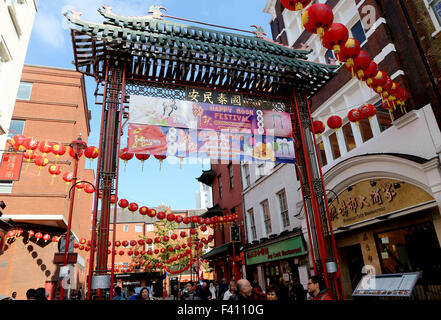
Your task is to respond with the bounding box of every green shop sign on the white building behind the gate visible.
[245,236,306,265]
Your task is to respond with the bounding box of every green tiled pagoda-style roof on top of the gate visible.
[65,9,337,95]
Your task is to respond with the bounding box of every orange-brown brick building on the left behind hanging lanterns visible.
[0,65,94,299]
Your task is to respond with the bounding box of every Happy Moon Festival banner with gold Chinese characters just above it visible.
[128,91,295,163]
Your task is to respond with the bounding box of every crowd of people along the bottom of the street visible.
[0,276,332,301]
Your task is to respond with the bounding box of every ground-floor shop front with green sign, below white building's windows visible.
[245,234,309,290]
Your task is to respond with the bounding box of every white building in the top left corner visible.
[0,0,38,155]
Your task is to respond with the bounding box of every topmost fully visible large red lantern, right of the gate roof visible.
[302,3,334,38]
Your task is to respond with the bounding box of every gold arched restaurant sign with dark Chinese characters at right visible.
[329,179,434,230]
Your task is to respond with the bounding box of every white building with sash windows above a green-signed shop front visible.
[241,162,310,290]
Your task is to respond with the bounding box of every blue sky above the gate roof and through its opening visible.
[25,0,271,209]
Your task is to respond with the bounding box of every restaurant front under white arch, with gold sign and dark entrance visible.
[329,178,441,300]
